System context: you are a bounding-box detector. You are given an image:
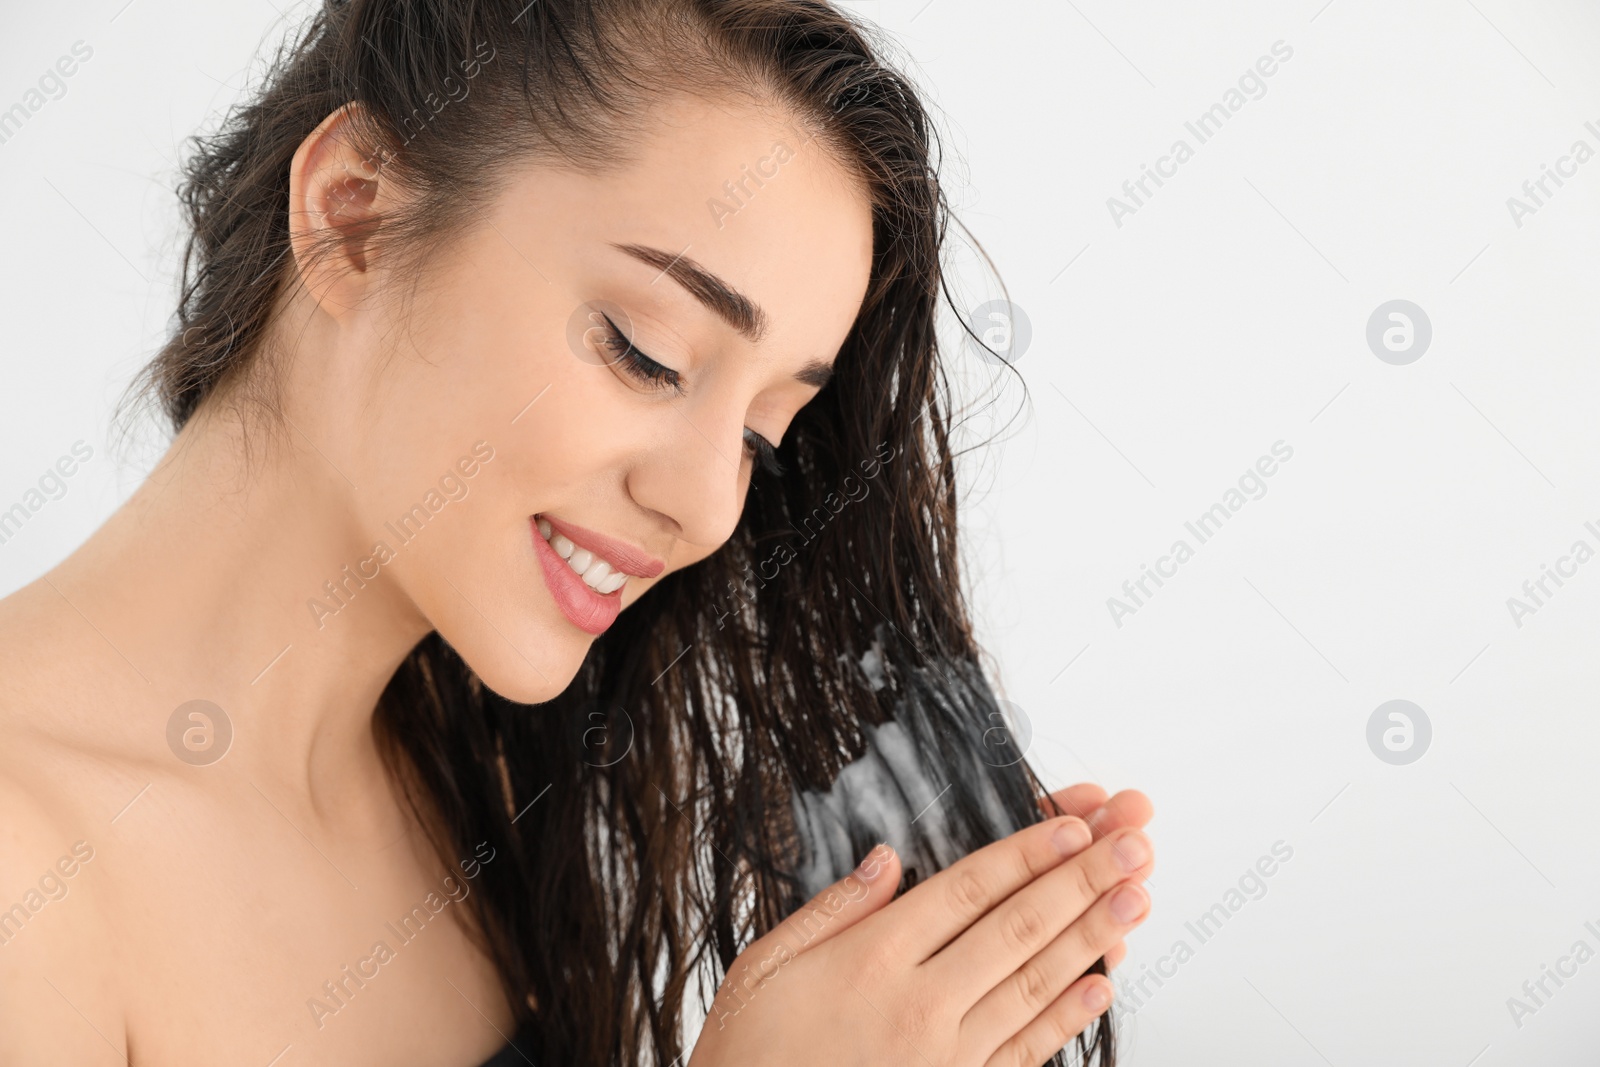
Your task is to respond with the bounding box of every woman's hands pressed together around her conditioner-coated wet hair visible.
[690,785,1152,1067]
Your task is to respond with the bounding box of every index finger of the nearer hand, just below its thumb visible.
[874,816,1091,959]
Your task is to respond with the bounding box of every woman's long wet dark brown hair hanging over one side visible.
[130,0,1114,1067]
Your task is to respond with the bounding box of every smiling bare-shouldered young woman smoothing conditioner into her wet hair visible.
[0,0,1150,1067]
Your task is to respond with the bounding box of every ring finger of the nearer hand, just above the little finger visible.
[962,881,1150,1048]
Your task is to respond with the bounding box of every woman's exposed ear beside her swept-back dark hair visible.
[288,102,394,318]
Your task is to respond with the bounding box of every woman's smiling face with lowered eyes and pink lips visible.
[298,98,872,702]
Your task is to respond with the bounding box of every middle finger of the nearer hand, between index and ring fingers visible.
[925,830,1154,1003]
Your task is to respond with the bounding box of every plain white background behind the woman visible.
[0,0,1600,1067]
